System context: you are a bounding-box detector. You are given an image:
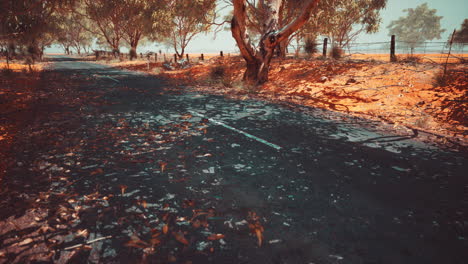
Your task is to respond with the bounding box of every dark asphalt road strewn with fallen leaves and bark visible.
[1,58,468,264]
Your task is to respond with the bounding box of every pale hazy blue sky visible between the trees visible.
[47,0,468,53]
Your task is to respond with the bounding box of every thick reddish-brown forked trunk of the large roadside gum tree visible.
[231,0,319,85]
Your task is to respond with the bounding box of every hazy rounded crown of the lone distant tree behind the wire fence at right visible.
[387,3,445,53]
